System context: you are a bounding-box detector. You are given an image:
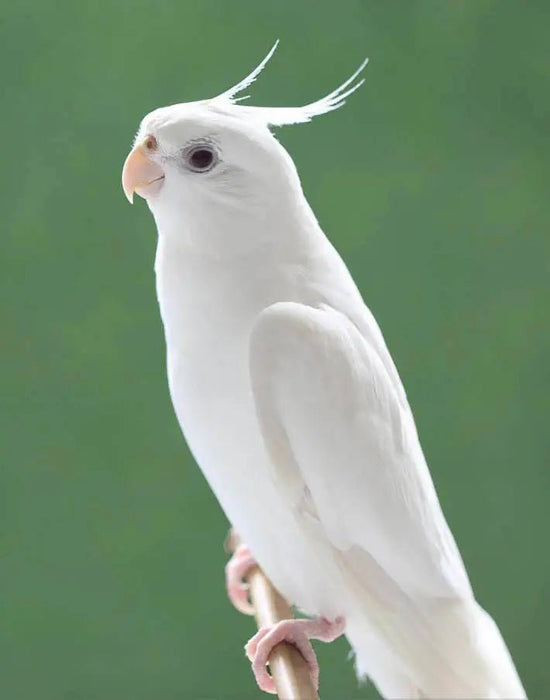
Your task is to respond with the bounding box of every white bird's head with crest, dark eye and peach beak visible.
[122,44,366,242]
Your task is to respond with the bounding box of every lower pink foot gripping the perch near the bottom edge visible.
[245,617,346,693]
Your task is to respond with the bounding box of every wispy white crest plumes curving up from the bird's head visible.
[214,39,369,126]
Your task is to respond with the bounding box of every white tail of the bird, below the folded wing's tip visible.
[346,599,527,700]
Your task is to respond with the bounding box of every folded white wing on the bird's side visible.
[250,302,471,596]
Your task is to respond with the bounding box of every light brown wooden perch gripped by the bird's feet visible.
[226,532,319,700]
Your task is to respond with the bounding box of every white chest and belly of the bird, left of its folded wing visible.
[157,253,348,615]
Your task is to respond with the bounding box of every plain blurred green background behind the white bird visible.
[0,0,550,700]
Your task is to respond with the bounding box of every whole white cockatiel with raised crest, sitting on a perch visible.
[123,47,525,699]
